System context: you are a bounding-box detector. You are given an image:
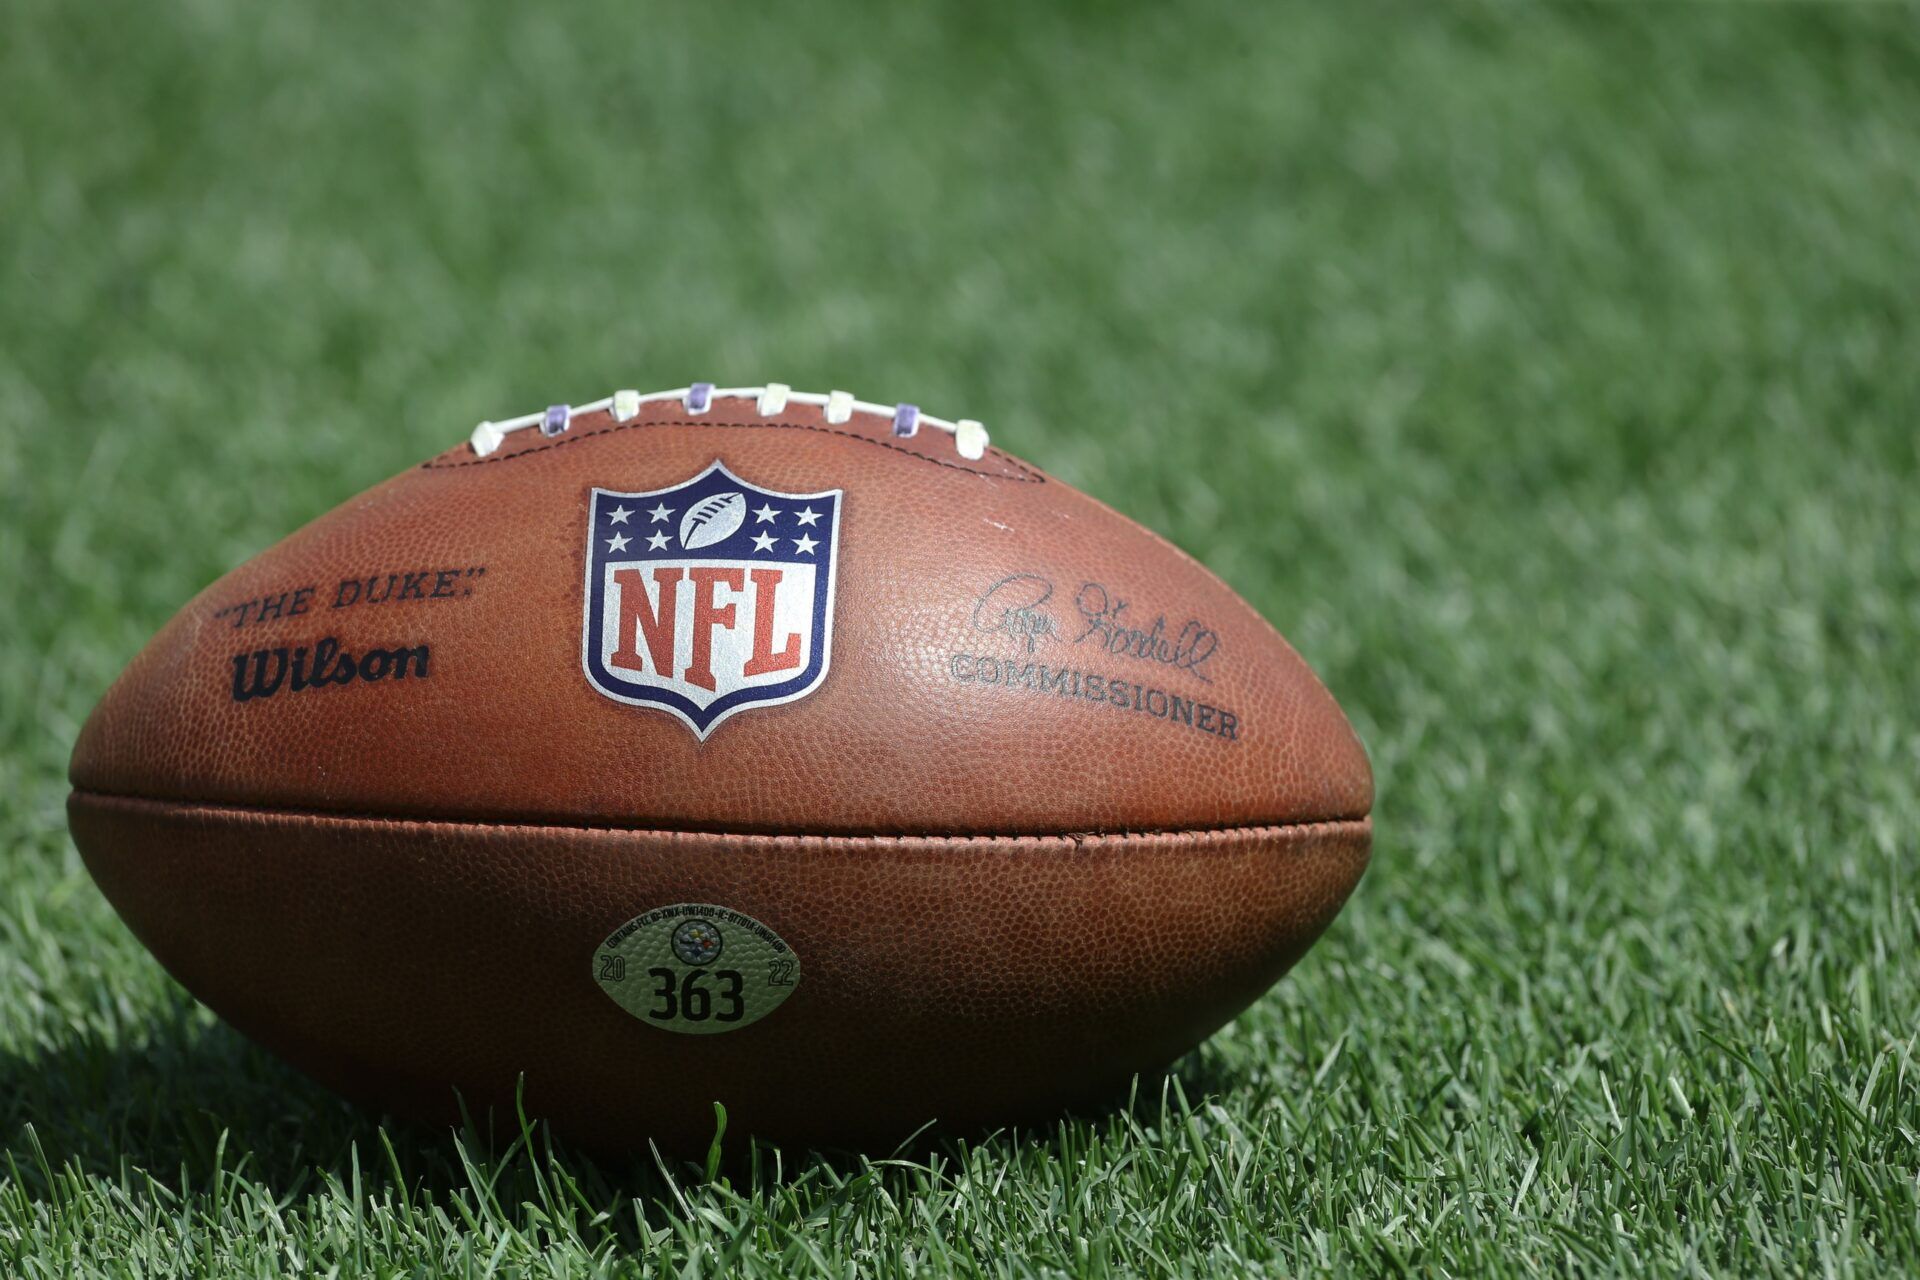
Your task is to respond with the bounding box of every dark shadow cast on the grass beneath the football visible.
[0,992,1244,1232]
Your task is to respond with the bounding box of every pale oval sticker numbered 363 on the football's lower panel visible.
[593,902,801,1036]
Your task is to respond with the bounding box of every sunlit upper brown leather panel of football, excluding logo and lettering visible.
[73,403,1373,835]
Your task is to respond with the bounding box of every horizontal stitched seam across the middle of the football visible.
[73,787,1373,844]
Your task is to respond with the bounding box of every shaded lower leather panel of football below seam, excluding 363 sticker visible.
[69,793,1369,1151]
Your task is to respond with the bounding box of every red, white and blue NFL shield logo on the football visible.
[582,462,841,739]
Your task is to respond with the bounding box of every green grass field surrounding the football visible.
[0,0,1920,1276]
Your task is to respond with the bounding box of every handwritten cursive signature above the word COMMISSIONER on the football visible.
[973,574,1219,683]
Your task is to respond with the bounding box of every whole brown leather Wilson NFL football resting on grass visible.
[69,384,1373,1150]
